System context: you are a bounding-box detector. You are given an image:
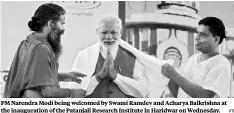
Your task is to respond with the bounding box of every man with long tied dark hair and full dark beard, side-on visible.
[4,3,86,98]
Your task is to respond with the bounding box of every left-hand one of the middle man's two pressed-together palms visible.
[95,50,109,82]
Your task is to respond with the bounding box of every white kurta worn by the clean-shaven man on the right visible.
[178,53,231,98]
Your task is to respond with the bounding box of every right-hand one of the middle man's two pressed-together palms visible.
[107,50,117,81]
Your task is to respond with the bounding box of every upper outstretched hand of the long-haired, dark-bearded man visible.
[59,72,87,84]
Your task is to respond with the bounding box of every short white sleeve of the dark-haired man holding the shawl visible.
[202,67,231,98]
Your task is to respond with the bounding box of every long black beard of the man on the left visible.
[47,30,62,60]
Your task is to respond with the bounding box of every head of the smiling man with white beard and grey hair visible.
[98,15,122,49]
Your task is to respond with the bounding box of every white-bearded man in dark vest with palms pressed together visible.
[70,15,172,98]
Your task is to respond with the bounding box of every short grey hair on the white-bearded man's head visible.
[98,14,122,28]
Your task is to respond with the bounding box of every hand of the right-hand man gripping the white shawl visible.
[161,63,177,79]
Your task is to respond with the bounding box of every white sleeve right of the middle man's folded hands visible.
[114,59,149,98]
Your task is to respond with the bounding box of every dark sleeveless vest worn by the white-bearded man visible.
[87,46,136,98]
